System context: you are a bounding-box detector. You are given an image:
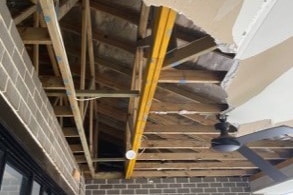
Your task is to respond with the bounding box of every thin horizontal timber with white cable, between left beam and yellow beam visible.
[76,90,139,98]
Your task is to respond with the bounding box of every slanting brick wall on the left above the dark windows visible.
[0,0,82,194]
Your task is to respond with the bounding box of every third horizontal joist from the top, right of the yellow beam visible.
[144,123,219,135]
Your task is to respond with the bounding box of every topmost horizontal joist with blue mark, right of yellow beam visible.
[159,69,227,84]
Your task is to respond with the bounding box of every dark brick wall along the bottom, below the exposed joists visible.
[86,177,251,195]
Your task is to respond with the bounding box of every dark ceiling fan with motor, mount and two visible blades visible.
[211,115,293,182]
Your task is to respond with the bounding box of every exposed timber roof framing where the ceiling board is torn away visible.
[7,0,293,178]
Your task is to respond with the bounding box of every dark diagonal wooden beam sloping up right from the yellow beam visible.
[163,35,217,70]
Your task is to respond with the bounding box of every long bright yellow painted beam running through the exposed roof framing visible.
[125,7,176,179]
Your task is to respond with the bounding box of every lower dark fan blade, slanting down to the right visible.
[238,145,288,182]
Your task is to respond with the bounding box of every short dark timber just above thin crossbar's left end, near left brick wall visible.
[39,76,65,90]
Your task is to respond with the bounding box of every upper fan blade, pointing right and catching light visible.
[236,126,293,145]
